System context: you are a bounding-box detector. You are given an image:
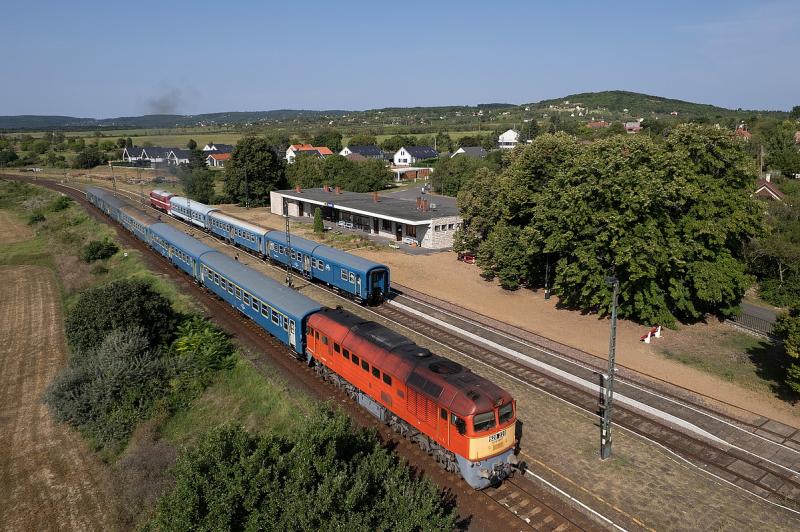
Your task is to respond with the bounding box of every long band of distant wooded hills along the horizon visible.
[0,91,786,131]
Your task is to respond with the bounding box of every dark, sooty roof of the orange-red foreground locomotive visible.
[320,308,511,416]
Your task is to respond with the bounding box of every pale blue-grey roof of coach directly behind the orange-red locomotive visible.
[200,251,322,320]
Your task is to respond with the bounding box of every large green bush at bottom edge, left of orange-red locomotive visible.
[151,409,456,530]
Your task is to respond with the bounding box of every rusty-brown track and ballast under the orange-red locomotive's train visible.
[9,179,611,531]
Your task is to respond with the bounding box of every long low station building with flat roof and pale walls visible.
[270,187,463,249]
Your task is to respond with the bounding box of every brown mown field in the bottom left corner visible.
[0,266,112,531]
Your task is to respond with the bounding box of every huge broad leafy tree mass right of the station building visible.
[458,125,761,325]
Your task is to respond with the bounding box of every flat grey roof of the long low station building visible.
[277,188,459,225]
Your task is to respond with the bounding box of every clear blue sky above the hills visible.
[0,0,800,118]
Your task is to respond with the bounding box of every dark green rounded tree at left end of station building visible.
[225,137,286,206]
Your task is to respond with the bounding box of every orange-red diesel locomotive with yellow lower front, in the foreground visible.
[306,308,518,489]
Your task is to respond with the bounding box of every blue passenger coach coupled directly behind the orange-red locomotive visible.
[200,251,322,356]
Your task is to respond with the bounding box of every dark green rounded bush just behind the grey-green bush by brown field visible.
[65,279,176,351]
